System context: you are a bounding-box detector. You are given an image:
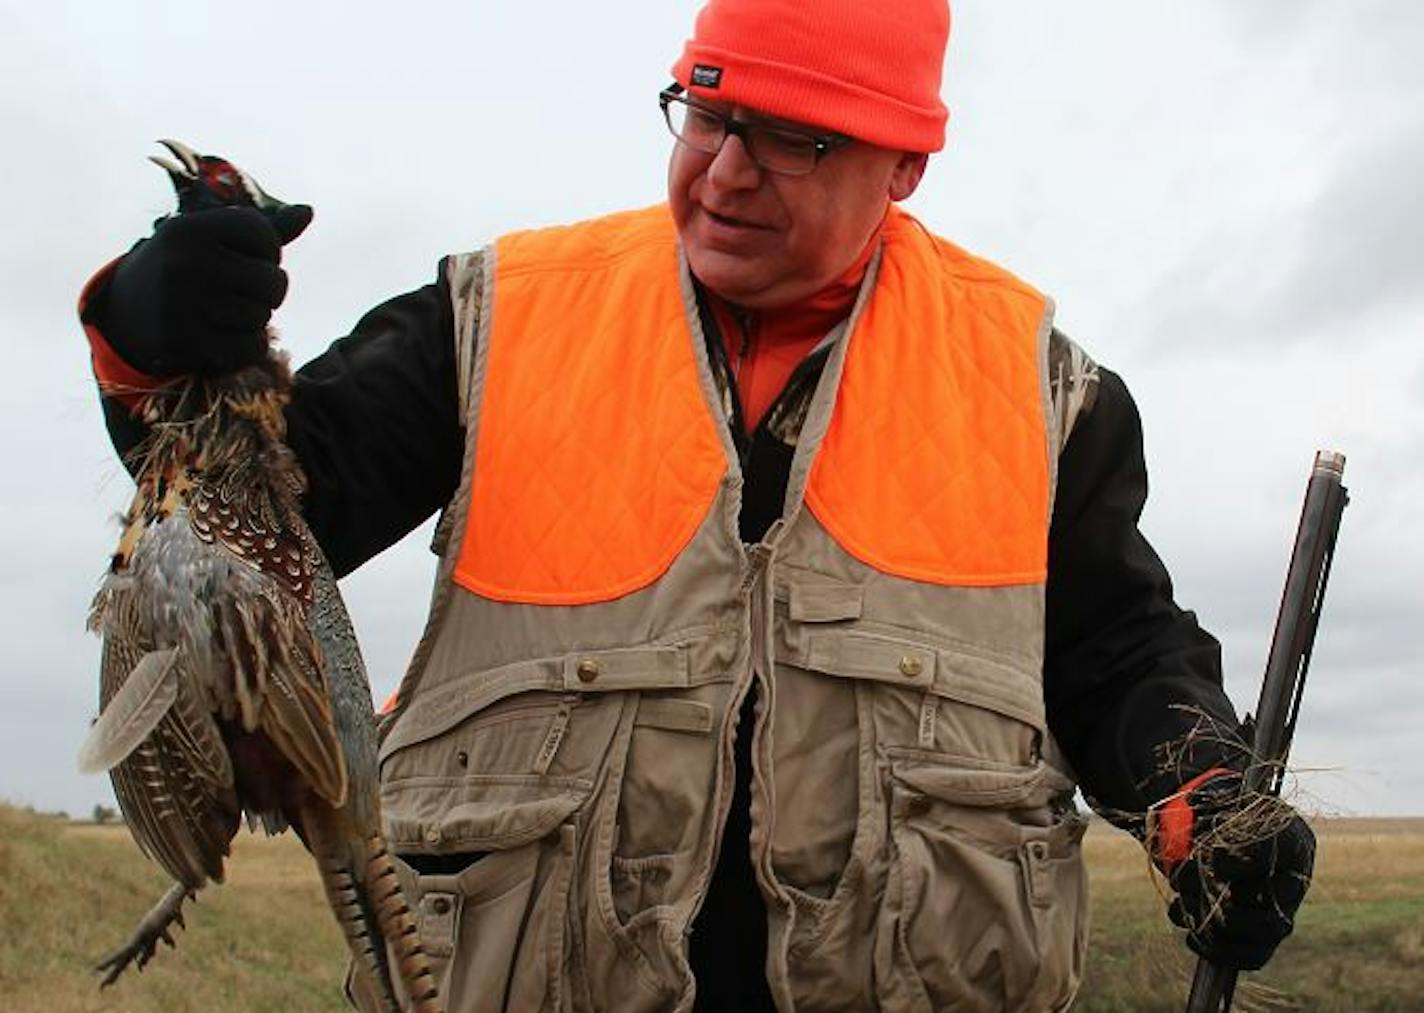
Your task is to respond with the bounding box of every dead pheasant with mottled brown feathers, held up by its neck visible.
[80,141,440,1013]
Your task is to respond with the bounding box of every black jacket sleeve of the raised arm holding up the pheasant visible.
[97,262,464,577]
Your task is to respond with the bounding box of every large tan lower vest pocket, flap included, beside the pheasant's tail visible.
[382,691,625,1013]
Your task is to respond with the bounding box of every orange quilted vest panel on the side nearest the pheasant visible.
[454,207,728,604]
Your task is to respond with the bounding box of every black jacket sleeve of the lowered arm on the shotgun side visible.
[1044,369,1240,826]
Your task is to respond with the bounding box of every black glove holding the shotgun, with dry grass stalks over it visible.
[1158,771,1316,970]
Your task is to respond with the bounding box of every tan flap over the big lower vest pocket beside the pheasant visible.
[382,776,592,853]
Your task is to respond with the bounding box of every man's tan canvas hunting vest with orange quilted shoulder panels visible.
[367,207,1087,1013]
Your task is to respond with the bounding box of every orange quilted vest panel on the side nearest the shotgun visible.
[806,209,1049,587]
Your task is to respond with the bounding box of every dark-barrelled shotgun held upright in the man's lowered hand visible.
[1186,450,1350,1013]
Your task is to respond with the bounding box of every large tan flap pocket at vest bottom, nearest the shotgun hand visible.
[877,749,1087,1013]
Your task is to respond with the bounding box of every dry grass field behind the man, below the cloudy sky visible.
[0,805,1424,1013]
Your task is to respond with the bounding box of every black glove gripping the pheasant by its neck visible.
[96,204,312,376]
